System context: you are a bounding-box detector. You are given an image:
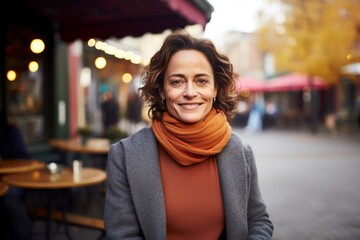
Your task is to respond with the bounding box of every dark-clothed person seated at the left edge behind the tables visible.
[0,112,31,240]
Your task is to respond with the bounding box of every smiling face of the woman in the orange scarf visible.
[161,50,216,123]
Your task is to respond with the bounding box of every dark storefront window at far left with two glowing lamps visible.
[5,26,45,143]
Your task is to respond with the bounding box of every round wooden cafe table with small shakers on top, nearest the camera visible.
[2,168,106,239]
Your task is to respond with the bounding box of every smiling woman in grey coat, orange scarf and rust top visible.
[104,31,273,240]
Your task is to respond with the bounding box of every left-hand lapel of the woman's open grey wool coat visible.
[121,128,166,240]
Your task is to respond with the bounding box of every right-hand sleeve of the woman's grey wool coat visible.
[245,145,274,240]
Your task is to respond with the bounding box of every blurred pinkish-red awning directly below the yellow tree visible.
[264,73,328,92]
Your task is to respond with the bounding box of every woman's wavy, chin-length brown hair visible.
[139,30,240,120]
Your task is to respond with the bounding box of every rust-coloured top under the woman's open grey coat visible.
[159,147,225,240]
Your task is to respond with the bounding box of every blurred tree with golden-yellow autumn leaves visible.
[258,0,360,83]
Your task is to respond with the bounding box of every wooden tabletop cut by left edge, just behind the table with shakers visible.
[0,159,45,174]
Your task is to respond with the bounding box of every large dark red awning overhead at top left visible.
[4,0,213,42]
